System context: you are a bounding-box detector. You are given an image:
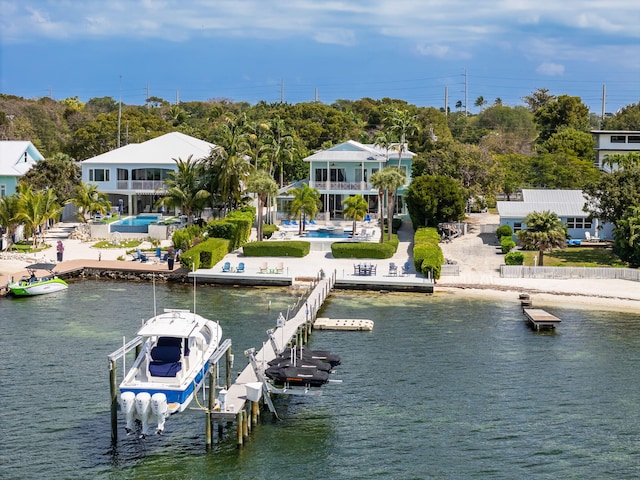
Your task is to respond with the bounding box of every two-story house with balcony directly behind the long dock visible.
[304,140,415,220]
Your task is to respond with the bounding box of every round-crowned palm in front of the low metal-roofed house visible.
[517,210,567,267]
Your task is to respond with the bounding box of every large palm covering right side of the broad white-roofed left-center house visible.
[157,155,211,225]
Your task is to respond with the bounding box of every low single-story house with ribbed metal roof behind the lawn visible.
[497,189,613,239]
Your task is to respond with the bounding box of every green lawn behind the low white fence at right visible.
[522,246,627,267]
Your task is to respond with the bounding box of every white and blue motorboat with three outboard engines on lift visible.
[120,309,222,436]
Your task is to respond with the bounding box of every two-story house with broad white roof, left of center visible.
[82,132,214,215]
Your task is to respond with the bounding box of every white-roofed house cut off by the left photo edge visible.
[0,140,44,197]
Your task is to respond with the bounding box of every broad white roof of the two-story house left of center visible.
[82,132,215,166]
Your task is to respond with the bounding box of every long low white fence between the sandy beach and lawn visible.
[500,265,640,282]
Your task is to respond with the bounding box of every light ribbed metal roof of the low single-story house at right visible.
[496,189,589,218]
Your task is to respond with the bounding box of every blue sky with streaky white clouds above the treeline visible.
[0,0,640,113]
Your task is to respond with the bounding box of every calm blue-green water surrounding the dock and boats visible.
[0,280,640,479]
